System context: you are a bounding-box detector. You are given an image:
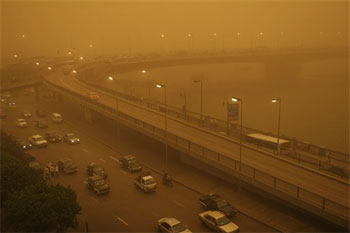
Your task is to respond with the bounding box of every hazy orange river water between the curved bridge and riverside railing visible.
[113,59,349,153]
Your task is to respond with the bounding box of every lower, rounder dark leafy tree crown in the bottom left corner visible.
[5,183,81,232]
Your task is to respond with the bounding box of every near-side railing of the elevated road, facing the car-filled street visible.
[44,78,349,223]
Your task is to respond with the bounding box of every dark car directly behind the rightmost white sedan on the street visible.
[199,193,238,218]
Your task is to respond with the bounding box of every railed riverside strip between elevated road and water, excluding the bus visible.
[78,73,349,179]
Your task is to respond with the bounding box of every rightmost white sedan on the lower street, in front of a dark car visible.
[199,210,239,233]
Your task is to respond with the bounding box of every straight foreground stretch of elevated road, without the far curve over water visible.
[44,57,349,226]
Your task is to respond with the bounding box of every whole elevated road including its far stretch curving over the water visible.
[2,50,349,227]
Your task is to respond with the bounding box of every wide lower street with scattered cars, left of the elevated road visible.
[2,78,344,232]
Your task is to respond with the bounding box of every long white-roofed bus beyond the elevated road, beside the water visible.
[246,133,292,153]
